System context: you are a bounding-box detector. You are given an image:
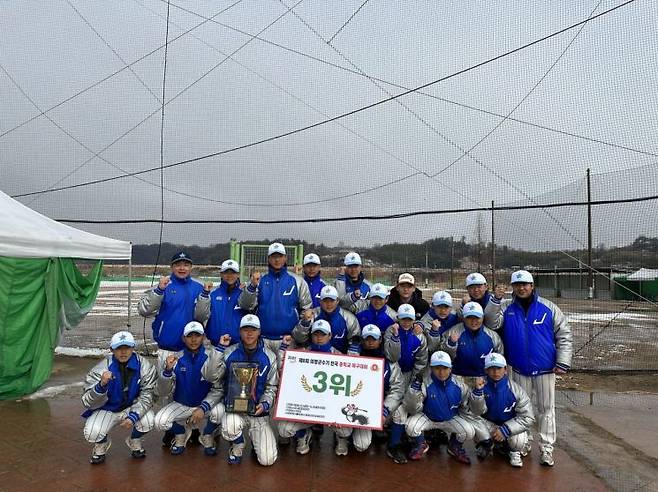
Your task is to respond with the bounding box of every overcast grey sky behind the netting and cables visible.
[0,0,658,249]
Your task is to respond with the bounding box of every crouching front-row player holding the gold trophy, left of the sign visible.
[218,314,279,466]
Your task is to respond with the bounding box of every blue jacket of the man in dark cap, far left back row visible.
[138,275,203,352]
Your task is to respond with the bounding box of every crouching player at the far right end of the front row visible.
[469,353,535,468]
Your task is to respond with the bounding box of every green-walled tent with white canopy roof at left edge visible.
[0,192,131,400]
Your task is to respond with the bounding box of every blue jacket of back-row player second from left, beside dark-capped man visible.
[205,280,245,346]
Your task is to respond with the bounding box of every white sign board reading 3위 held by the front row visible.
[274,350,384,430]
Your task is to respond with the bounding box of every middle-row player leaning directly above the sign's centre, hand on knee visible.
[292,285,361,355]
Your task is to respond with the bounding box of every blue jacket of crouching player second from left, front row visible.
[167,345,212,407]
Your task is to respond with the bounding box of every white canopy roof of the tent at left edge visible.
[0,191,132,260]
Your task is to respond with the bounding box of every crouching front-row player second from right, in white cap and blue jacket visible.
[404,351,475,464]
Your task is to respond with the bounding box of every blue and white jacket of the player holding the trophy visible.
[224,339,279,415]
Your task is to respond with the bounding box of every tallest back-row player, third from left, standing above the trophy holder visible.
[238,243,313,353]
